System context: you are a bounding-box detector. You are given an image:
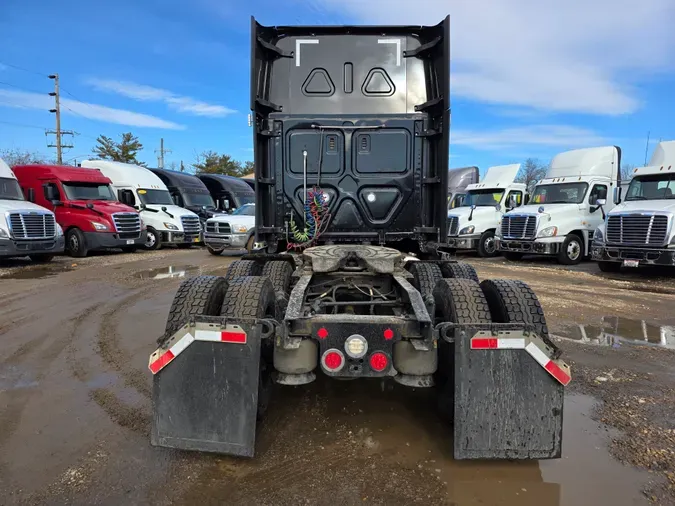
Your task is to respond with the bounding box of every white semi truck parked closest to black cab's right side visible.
[448,163,527,258]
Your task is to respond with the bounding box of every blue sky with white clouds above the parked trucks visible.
[0,0,675,169]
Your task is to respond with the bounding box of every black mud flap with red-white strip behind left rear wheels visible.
[150,323,260,457]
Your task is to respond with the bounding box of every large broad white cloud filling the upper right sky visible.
[305,0,675,115]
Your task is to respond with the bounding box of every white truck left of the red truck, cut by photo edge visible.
[0,159,65,262]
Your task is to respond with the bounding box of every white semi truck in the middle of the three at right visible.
[496,146,621,265]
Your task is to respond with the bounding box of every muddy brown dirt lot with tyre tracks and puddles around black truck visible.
[0,249,675,506]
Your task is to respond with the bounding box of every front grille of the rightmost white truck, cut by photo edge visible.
[607,214,668,246]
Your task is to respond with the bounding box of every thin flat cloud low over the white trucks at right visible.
[450,125,610,151]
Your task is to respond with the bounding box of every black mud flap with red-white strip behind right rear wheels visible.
[454,328,569,459]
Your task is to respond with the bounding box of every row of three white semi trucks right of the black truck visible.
[448,141,675,272]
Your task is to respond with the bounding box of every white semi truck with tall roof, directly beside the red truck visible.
[80,160,202,250]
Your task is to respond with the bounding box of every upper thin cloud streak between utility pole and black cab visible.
[87,78,237,118]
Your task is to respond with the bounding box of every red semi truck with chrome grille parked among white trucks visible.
[13,165,145,257]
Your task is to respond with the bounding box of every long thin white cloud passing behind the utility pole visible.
[0,89,185,130]
